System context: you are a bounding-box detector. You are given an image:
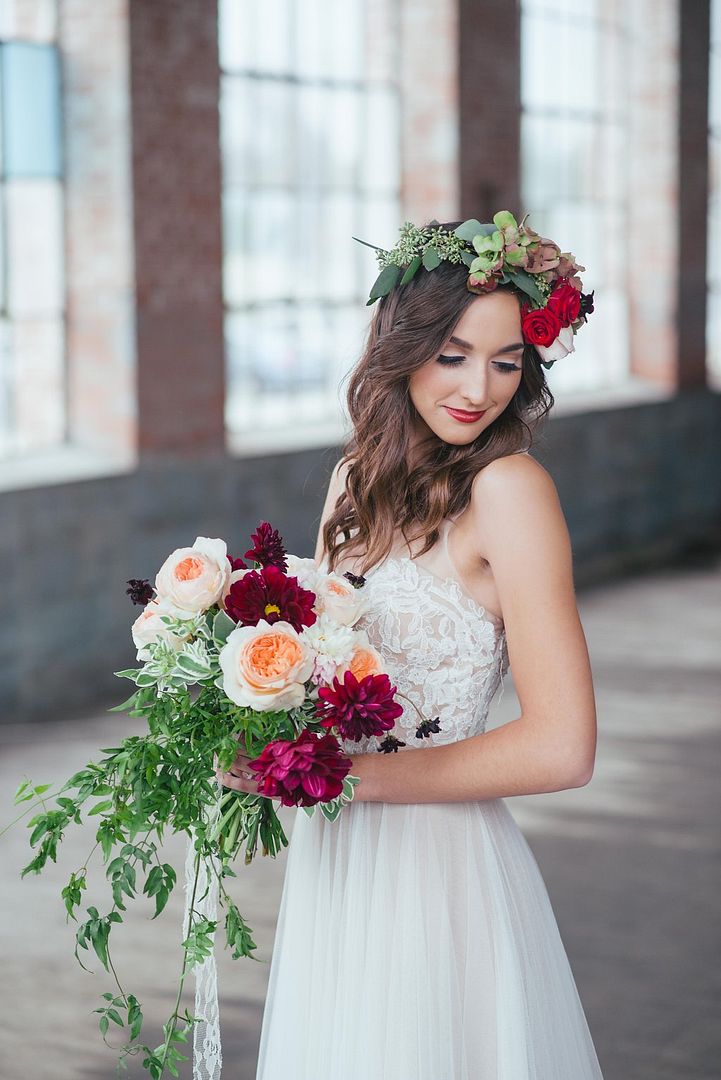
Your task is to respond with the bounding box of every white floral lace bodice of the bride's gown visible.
[317,518,508,754]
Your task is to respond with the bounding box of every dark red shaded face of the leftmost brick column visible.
[128,0,225,459]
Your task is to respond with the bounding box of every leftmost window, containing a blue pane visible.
[0,2,66,457]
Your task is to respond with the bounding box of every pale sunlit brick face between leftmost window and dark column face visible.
[58,0,136,458]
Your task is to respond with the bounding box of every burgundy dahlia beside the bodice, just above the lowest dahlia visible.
[316,667,403,742]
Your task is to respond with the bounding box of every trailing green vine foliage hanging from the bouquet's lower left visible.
[8,673,298,1080]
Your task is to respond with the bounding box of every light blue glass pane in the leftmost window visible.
[0,41,62,178]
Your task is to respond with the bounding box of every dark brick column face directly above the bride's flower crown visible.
[458,0,525,221]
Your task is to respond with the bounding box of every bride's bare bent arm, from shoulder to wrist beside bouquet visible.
[351,455,596,802]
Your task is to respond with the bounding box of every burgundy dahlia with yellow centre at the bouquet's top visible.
[225,565,317,633]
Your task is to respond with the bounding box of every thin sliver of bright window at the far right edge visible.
[706,0,721,390]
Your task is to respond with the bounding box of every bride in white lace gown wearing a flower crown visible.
[222,211,601,1080]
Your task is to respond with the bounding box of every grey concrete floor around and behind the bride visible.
[0,559,721,1080]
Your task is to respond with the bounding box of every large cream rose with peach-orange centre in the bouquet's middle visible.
[219,619,315,712]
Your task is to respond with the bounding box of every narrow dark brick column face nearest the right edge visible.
[677,0,710,389]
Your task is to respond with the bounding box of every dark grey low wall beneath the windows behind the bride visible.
[0,390,721,723]
